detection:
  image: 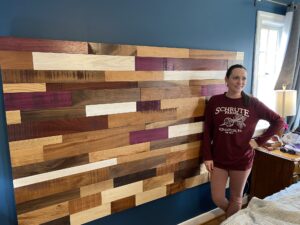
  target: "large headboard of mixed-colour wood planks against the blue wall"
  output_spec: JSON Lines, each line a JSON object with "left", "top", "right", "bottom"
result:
{"left": 0, "top": 37, "right": 244, "bottom": 225}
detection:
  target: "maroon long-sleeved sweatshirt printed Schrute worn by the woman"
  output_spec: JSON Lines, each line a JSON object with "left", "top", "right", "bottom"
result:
{"left": 202, "top": 93, "right": 283, "bottom": 170}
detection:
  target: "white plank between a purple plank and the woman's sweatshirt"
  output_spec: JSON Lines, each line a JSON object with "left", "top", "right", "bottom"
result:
{"left": 168, "top": 122, "right": 203, "bottom": 138}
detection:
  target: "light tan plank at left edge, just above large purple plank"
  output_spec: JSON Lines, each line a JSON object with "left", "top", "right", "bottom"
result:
{"left": 3, "top": 83, "right": 46, "bottom": 93}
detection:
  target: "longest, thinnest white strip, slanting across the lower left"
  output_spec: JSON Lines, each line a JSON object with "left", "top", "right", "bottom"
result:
{"left": 13, "top": 158, "right": 117, "bottom": 188}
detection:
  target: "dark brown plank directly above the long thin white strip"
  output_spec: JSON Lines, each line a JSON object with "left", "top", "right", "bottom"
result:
{"left": 13, "top": 154, "right": 89, "bottom": 179}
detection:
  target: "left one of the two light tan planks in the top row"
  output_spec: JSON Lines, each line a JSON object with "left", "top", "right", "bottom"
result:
{"left": 137, "top": 46, "right": 189, "bottom": 58}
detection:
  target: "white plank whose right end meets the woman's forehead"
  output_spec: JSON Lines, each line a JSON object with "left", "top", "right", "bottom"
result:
{"left": 164, "top": 70, "right": 226, "bottom": 80}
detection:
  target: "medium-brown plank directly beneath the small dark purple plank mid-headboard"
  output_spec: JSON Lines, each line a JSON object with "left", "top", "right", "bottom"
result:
{"left": 108, "top": 109, "right": 177, "bottom": 128}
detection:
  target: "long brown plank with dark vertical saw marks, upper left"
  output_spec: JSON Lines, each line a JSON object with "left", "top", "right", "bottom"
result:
{"left": 2, "top": 68, "right": 105, "bottom": 83}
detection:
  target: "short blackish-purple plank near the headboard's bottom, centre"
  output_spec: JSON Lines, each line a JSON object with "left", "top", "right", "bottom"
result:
{"left": 114, "top": 168, "right": 156, "bottom": 187}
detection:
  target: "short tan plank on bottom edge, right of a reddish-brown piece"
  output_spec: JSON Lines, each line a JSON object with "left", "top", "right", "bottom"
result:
{"left": 135, "top": 186, "right": 167, "bottom": 205}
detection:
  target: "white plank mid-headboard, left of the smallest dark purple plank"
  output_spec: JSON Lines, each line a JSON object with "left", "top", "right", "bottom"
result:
{"left": 85, "top": 102, "right": 136, "bottom": 116}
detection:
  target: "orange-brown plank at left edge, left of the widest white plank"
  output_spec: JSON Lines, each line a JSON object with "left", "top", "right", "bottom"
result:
{"left": 0, "top": 51, "right": 33, "bottom": 70}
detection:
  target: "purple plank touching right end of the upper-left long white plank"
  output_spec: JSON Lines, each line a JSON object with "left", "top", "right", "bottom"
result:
{"left": 135, "top": 57, "right": 166, "bottom": 71}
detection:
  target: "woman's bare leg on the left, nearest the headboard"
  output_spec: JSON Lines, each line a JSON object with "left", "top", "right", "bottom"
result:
{"left": 210, "top": 167, "right": 228, "bottom": 211}
